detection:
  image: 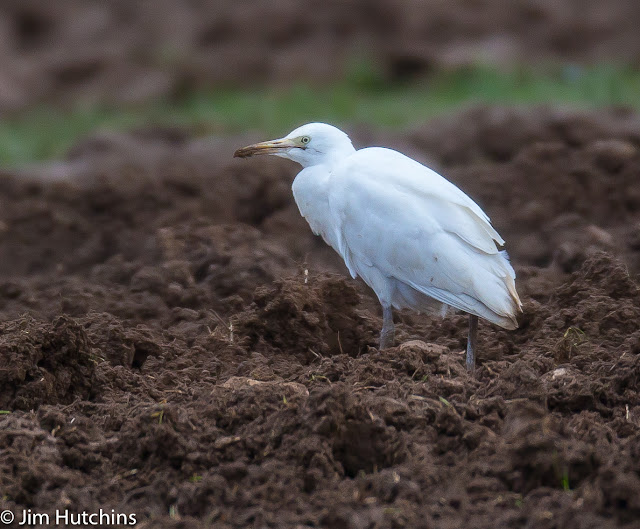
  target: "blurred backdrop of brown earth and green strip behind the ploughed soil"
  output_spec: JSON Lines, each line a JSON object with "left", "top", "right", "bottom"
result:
{"left": 0, "top": 0, "right": 640, "bottom": 165}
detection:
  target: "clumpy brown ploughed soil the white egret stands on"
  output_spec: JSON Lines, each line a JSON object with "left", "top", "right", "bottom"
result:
{"left": 0, "top": 105, "right": 640, "bottom": 529}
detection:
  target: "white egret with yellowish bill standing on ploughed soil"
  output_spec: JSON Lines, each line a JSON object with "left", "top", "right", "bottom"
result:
{"left": 234, "top": 123, "right": 522, "bottom": 370}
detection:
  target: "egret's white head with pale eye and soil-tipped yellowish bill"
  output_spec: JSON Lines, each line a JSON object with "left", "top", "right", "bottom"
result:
{"left": 233, "top": 123, "right": 355, "bottom": 167}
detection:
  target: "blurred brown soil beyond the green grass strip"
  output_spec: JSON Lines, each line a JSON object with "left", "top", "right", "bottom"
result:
{"left": 0, "top": 0, "right": 640, "bottom": 111}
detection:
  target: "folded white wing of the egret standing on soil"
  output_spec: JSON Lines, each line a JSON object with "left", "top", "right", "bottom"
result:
{"left": 328, "top": 144, "right": 520, "bottom": 328}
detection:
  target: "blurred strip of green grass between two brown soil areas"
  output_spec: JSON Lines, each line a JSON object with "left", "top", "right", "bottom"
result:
{"left": 0, "top": 64, "right": 640, "bottom": 166}
